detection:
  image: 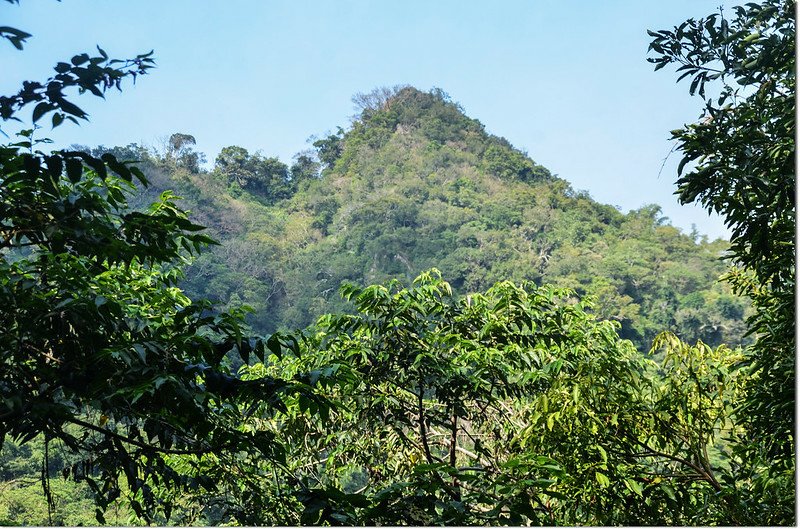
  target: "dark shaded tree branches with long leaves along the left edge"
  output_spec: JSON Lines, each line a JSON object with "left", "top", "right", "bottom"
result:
{"left": 0, "top": 9, "right": 324, "bottom": 524}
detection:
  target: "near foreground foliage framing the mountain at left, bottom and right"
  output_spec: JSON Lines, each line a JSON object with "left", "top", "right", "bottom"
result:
{"left": 0, "top": 0, "right": 794, "bottom": 525}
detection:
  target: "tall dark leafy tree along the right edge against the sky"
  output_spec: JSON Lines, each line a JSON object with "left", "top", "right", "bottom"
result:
{"left": 648, "top": 0, "right": 796, "bottom": 524}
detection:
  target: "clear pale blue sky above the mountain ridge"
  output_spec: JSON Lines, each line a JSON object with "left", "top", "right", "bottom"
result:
{"left": 0, "top": 0, "right": 737, "bottom": 238}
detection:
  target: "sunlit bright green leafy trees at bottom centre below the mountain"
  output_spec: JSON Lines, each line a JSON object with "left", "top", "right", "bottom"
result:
{"left": 241, "top": 270, "right": 751, "bottom": 525}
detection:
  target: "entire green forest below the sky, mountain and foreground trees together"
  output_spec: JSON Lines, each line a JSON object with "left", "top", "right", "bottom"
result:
{"left": 0, "top": 0, "right": 796, "bottom": 525}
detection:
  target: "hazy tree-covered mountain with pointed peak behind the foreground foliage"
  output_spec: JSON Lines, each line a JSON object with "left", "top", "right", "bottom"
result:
{"left": 101, "top": 87, "right": 746, "bottom": 351}
